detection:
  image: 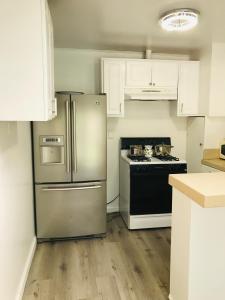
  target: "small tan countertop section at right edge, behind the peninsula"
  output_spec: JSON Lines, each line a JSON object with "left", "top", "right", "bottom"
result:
{"left": 202, "top": 149, "right": 225, "bottom": 172}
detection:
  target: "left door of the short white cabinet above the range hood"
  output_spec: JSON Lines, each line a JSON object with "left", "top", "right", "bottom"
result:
{"left": 126, "top": 60, "right": 152, "bottom": 87}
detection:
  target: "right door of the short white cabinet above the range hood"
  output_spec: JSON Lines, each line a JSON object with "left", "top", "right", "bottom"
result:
{"left": 152, "top": 61, "right": 178, "bottom": 87}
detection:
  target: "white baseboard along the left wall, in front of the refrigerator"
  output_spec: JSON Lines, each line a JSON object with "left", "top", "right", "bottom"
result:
{"left": 16, "top": 237, "right": 37, "bottom": 300}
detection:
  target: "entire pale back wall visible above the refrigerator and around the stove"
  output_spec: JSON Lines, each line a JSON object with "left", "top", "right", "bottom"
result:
{"left": 55, "top": 49, "right": 186, "bottom": 211}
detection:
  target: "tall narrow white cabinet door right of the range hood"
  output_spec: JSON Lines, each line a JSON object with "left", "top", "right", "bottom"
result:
{"left": 177, "top": 61, "right": 199, "bottom": 116}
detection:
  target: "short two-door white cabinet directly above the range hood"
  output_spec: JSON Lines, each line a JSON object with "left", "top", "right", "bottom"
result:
{"left": 126, "top": 59, "right": 178, "bottom": 87}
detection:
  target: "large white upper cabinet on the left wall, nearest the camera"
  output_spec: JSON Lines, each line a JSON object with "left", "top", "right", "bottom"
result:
{"left": 0, "top": 0, "right": 55, "bottom": 121}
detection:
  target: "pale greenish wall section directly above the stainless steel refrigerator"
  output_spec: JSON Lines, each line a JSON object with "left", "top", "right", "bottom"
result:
{"left": 55, "top": 49, "right": 142, "bottom": 94}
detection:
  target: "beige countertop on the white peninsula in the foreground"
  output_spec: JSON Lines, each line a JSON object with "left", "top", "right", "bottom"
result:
{"left": 169, "top": 172, "right": 225, "bottom": 208}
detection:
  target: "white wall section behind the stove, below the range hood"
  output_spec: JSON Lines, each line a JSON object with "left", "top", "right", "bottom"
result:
{"left": 108, "top": 101, "right": 186, "bottom": 212}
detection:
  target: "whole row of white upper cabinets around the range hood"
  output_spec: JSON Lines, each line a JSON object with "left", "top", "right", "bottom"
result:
{"left": 102, "top": 58, "right": 200, "bottom": 117}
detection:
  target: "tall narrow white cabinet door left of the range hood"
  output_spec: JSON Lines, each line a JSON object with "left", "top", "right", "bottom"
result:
{"left": 102, "top": 59, "right": 125, "bottom": 117}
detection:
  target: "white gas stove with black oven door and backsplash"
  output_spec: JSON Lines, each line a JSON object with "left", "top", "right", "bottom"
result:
{"left": 120, "top": 138, "right": 187, "bottom": 229}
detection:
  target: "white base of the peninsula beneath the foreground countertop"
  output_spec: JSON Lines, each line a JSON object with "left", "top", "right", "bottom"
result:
{"left": 169, "top": 190, "right": 225, "bottom": 300}
